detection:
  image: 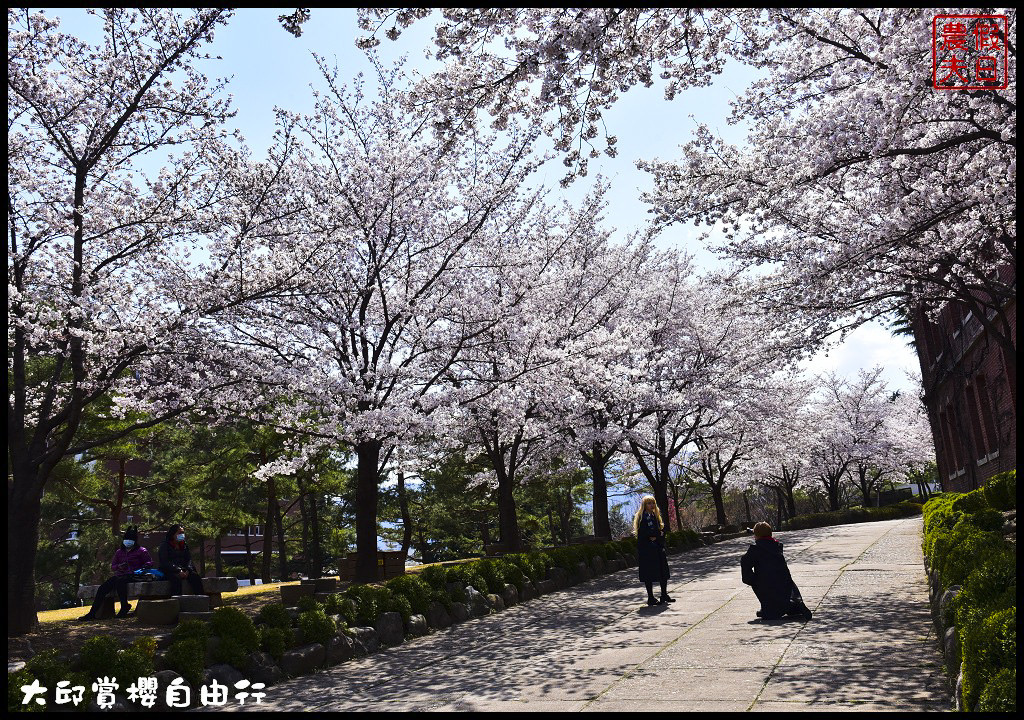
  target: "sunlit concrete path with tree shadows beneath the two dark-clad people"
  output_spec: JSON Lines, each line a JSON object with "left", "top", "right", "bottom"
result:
{"left": 225, "top": 517, "right": 950, "bottom": 712}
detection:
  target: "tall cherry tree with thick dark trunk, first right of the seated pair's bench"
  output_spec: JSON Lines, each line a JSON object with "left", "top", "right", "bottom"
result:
{"left": 233, "top": 60, "right": 537, "bottom": 581}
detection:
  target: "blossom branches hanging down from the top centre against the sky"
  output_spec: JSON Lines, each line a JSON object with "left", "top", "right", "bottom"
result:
{"left": 358, "top": 7, "right": 765, "bottom": 184}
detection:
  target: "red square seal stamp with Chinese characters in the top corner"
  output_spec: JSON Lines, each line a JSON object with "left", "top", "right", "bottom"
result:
{"left": 932, "top": 15, "right": 1010, "bottom": 90}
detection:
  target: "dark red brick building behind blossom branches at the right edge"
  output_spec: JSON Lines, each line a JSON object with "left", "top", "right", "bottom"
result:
{"left": 913, "top": 266, "right": 1017, "bottom": 492}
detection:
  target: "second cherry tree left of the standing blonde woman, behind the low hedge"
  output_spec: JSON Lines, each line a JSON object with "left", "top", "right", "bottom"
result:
{"left": 451, "top": 184, "right": 625, "bottom": 549}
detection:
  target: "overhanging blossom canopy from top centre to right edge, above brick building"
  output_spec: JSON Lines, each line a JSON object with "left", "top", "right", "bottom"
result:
{"left": 360, "top": 8, "right": 1017, "bottom": 359}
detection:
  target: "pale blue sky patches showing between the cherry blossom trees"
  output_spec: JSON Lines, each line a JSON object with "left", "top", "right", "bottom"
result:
{"left": 46, "top": 8, "right": 920, "bottom": 392}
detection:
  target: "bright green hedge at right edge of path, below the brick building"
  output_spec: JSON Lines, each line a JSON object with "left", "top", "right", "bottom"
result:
{"left": 923, "top": 471, "right": 1017, "bottom": 712}
